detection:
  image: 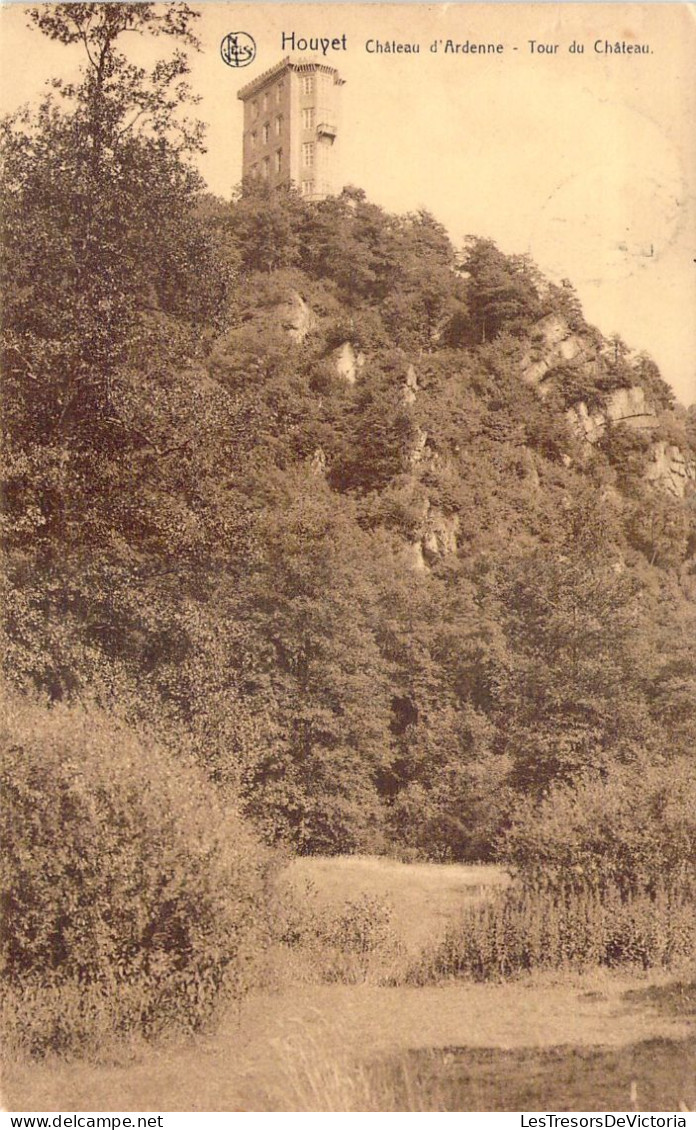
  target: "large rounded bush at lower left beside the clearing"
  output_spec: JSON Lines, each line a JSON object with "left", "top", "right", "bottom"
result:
{"left": 0, "top": 695, "right": 270, "bottom": 1053}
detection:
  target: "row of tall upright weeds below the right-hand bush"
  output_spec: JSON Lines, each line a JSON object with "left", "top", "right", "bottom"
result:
{"left": 410, "top": 887, "right": 696, "bottom": 983}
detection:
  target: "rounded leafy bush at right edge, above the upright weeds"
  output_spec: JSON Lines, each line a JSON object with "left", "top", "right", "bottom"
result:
{"left": 501, "top": 760, "right": 696, "bottom": 896}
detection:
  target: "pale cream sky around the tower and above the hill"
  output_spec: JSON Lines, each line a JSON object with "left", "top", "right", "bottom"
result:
{"left": 0, "top": 2, "right": 696, "bottom": 405}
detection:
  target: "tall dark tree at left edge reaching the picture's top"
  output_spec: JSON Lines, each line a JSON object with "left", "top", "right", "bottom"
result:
{"left": 1, "top": 3, "right": 230, "bottom": 694}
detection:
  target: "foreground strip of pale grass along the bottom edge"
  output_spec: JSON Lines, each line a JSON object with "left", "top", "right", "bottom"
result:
{"left": 5, "top": 974, "right": 693, "bottom": 1111}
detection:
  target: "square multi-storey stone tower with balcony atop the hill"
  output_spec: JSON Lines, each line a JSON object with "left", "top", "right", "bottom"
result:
{"left": 237, "top": 58, "right": 343, "bottom": 200}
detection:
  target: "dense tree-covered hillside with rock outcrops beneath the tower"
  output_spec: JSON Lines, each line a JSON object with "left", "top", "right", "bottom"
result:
{"left": 5, "top": 171, "right": 696, "bottom": 859}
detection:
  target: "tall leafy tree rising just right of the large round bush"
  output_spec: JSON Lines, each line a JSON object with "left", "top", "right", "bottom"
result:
{"left": 217, "top": 471, "right": 397, "bottom": 852}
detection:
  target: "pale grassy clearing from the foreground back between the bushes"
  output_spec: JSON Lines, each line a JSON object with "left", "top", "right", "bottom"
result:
{"left": 5, "top": 858, "right": 696, "bottom": 1112}
